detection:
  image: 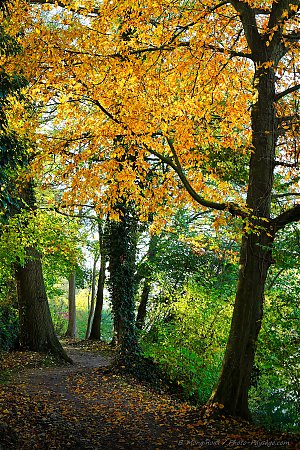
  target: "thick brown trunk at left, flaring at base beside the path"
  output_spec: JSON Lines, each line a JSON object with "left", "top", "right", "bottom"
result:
{"left": 16, "top": 248, "right": 72, "bottom": 362}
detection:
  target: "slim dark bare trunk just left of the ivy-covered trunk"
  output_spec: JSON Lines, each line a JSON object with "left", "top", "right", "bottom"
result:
{"left": 89, "top": 222, "right": 107, "bottom": 341}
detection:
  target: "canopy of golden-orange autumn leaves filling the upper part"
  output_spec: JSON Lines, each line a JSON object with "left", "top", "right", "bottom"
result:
{"left": 4, "top": 0, "right": 298, "bottom": 226}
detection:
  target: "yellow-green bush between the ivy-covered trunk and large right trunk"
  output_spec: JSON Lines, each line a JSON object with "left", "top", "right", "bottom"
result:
{"left": 142, "top": 284, "right": 232, "bottom": 403}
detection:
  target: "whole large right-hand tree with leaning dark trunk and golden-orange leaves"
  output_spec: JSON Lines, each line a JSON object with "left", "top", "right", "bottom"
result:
{"left": 11, "top": 0, "right": 300, "bottom": 418}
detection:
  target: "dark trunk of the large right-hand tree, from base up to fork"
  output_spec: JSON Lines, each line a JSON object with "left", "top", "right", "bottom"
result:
{"left": 210, "top": 57, "right": 277, "bottom": 418}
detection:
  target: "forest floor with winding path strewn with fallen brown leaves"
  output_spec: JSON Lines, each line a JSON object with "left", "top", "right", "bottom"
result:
{"left": 0, "top": 342, "right": 300, "bottom": 450}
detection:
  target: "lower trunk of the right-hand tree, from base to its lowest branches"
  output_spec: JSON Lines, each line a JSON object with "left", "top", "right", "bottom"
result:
{"left": 211, "top": 234, "right": 271, "bottom": 419}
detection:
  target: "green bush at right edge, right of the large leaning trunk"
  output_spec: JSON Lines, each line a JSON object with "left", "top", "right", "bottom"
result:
{"left": 250, "top": 288, "right": 300, "bottom": 431}
